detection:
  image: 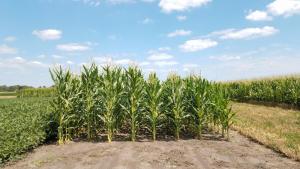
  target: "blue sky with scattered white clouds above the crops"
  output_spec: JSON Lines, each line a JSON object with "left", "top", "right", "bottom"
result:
{"left": 0, "top": 0, "right": 300, "bottom": 86}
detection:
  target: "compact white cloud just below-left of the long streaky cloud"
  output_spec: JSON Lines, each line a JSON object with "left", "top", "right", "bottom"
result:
{"left": 179, "top": 39, "right": 218, "bottom": 52}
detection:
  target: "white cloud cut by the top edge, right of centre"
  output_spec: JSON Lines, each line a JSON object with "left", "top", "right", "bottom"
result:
{"left": 159, "top": 0, "right": 211, "bottom": 13}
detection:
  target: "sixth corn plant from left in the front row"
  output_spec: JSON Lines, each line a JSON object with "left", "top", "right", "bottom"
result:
{"left": 166, "top": 74, "right": 187, "bottom": 140}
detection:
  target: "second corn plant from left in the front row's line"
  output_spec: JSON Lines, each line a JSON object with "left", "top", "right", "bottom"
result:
{"left": 81, "top": 64, "right": 99, "bottom": 140}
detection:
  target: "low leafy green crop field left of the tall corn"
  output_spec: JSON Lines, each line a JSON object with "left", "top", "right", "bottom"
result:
{"left": 0, "top": 98, "right": 51, "bottom": 164}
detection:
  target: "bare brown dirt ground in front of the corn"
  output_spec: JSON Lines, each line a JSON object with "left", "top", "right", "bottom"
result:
{"left": 5, "top": 131, "right": 300, "bottom": 169}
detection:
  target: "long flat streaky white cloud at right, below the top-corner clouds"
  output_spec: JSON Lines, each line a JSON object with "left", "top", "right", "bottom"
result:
{"left": 221, "top": 26, "right": 279, "bottom": 39}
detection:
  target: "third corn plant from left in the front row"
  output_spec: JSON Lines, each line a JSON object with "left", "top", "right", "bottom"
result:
{"left": 98, "top": 66, "right": 124, "bottom": 142}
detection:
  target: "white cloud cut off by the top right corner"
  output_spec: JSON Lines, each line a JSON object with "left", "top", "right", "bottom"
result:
{"left": 267, "top": 0, "right": 300, "bottom": 16}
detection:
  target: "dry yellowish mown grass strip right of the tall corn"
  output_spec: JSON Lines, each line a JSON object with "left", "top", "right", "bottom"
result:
{"left": 232, "top": 103, "right": 300, "bottom": 160}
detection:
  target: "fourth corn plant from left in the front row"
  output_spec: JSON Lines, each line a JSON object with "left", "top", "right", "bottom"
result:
{"left": 123, "top": 67, "right": 145, "bottom": 141}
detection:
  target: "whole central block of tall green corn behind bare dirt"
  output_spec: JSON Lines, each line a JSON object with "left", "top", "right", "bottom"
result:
{"left": 51, "top": 64, "right": 234, "bottom": 144}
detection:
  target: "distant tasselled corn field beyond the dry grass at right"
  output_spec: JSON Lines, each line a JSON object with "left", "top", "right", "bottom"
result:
{"left": 225, "top": 76, "right": 300, "bottom": 107}
